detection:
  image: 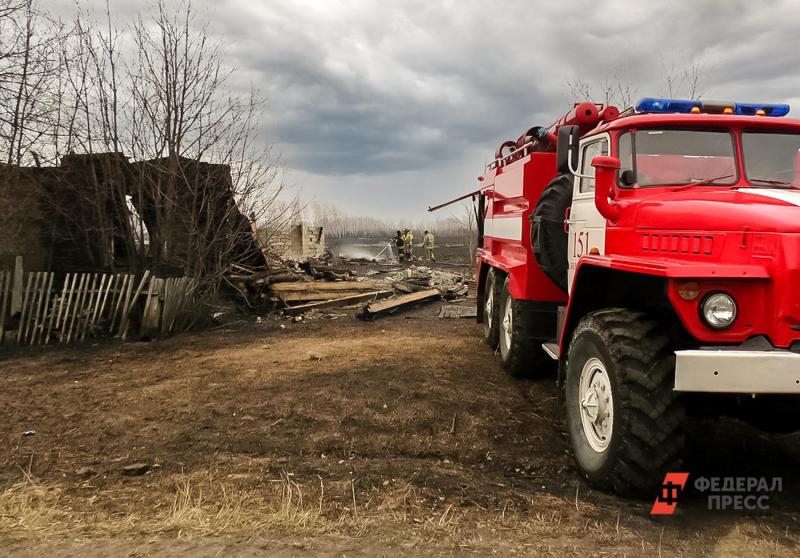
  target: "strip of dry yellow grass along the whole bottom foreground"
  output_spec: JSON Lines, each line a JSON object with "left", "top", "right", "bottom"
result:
{"left": 0, "top": 472, "right": 797, "bottom": 555}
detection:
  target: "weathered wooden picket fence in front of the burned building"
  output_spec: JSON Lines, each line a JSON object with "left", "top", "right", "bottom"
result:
{"left": 0, "top": 262, "right": 195, "bottom": 345}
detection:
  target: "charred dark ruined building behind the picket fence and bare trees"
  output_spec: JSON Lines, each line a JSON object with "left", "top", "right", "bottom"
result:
{"left": 0, "top": 153, "right": 266, "bottom": 276}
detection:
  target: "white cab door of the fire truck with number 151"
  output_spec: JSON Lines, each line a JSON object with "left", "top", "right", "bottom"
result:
{"left": 567, "top": 134, "right": 609, "bottom": 291}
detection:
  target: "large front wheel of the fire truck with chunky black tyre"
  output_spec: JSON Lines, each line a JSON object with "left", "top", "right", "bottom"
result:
{"left": 565, "top": 308, "right": 686, "bottom": 497}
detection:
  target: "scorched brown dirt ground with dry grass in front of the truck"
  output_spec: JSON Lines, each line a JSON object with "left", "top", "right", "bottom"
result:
{"left": 0, "top": 290, "right": 800, "bottom": 557}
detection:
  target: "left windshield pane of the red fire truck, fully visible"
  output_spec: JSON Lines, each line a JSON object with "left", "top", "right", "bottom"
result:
{"left": 618, "top": 129, "right": 737, "bottom": 187}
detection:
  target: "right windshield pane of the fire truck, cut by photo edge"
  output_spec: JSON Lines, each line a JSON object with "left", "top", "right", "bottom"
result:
{"left": 742, "top": 131, "right": 800, "bottom": 185}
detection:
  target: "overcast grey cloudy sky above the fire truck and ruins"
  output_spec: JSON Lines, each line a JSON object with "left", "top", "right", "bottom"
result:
{"left": 57, "top": 0, "right": 800, "bottom": 219}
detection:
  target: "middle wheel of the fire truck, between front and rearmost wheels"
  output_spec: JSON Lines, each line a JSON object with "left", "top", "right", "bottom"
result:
{"left": 497, "top": 277, "right": 555, "bottom": 378}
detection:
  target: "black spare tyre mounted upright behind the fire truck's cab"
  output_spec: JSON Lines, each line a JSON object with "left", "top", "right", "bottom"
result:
{"left": 531, "top": 174, "right": 572, "bottom": 292}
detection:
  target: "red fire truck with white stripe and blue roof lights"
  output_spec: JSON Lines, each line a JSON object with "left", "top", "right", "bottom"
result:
{"left": 432, "top": 98, "right": 800, "bottom": 494}
